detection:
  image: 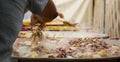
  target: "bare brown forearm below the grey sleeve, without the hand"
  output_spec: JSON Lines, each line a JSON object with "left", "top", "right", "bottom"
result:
{"left": 35, "top": 0, "right": 58, "bottom": 22}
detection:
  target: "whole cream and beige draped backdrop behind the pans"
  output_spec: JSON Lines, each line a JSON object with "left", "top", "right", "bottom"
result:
{"left": 24, "top": 0, "right": 120, "bottom": 37}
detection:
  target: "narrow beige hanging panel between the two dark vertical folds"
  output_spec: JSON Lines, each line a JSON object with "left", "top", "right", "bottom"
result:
{"left": 93, "top": 0, "right": 104, "bottom": 33}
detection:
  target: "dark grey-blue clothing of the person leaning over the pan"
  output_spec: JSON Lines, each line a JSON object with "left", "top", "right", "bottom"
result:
{"left": 0, "top": 0, "right": 48, "bottom": 62}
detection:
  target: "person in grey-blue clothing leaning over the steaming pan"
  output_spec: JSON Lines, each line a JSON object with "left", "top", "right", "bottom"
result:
{"left": 0, "top": 0, "right": 58, "bottom": 62}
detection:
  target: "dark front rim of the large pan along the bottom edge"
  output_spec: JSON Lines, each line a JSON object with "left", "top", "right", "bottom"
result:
{"left": 12, "top": 57, "right": 120, "bottom": 62}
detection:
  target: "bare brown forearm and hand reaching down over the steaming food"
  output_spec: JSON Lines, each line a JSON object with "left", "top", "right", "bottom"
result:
{"left": 31, "top": 0, "right": 58, "bottom": 28}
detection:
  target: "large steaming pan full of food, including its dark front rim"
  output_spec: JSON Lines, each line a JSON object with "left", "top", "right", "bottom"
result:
{"left": 12, "top": 31, "right": 120, "bottom": 62}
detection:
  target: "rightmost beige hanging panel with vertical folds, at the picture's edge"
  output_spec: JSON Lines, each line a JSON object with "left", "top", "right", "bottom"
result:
{"left": 105, "top": 0, "right": 120, "bottom": 37}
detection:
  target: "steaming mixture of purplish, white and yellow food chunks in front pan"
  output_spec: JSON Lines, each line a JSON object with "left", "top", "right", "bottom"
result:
{"left": 12, "top": 38, "right": 120, "bottom": 58}
